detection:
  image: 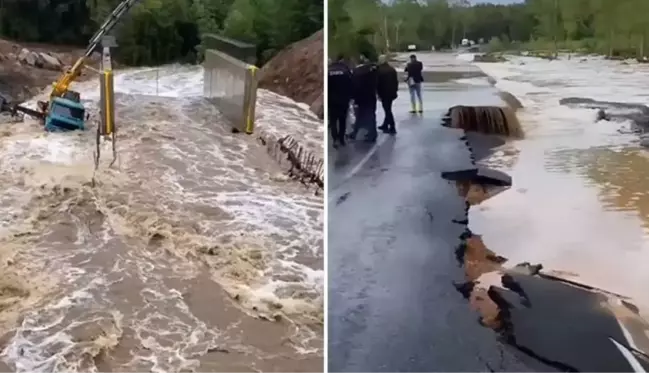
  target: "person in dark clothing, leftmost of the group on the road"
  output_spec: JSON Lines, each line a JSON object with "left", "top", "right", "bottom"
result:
{"left": 327, "top": 55, "right": 353, "bottom": 148}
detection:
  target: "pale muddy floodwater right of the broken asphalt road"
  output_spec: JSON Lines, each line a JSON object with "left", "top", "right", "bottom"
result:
{"left": 454, "top": 57, "right": 649, "bottom": 309}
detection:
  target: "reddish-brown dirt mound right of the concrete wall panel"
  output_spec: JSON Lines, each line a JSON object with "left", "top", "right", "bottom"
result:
{"left": 259, "top": 30, "right": 324, "bottom": 118}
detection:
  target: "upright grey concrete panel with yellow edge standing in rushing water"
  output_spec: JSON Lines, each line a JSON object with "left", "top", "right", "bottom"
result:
{"left": 203, "top": 49, "right": 258, "bottom": 134}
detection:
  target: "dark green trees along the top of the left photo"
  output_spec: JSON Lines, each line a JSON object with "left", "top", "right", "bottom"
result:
{"left": 0, "top": 0, "right": 324, "bottom": 65}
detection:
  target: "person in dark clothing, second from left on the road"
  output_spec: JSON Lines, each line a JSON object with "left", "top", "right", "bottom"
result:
{"left": 349, "top": 56, "right": 378, "bottom": 142}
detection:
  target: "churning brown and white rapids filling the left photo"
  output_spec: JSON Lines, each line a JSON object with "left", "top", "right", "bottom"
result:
{"left": 0, "top": 65, "right": 323, "bottom": 373}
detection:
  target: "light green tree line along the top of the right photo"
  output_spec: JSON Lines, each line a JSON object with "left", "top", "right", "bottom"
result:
{"left": 329, "top": 0, "right": 649, "bottom": 58}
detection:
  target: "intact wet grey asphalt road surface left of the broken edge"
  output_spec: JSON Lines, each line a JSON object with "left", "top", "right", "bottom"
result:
{"left": 328, "top": 84, "right": 531, "bottom": 373}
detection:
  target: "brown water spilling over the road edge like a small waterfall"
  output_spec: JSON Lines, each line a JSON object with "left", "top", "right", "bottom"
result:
{"left": 443, "top": 106, "right": 523, "bottom": 138}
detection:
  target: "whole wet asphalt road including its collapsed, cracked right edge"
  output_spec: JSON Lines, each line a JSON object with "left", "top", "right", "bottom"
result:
{"left": 328, "top": 55, "right": 648, "bottom": 373}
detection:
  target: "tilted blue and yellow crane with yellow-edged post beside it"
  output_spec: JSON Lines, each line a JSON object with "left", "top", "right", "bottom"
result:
{"left": 0, "top": 0, "right": 139, "bottom": 135}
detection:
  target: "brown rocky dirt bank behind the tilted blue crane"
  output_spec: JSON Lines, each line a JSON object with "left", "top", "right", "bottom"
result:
{"left": 0, "top": 39, "right": 98, "bottom": 101}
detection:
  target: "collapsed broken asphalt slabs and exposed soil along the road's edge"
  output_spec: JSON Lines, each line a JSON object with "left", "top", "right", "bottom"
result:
{"left": 443, "top": 114, "right": 649, "bottom": 373}
